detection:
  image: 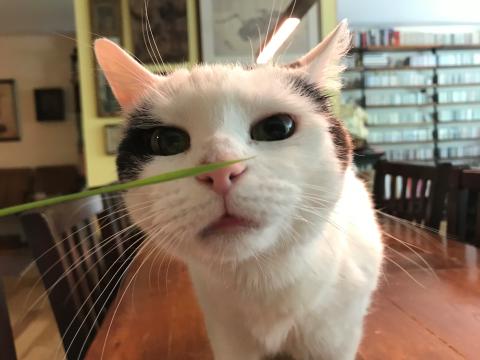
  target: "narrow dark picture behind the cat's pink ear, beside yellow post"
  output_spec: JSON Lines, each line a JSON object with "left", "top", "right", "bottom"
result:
{"left": 90, "top": 0, "right": 123, "bottom": 117}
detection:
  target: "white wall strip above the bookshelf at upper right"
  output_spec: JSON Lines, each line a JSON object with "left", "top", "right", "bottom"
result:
{"left": 337, "top": 0, "right": 480, "bottom": 26}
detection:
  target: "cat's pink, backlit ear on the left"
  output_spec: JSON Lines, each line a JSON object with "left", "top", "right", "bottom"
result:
{"left": 94, "top": 39, "right": 159, "bottom": 111}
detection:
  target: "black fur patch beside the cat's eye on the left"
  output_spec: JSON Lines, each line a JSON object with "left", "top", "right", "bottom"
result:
{"left": 117, "top": 106, "right": 153, "bottom": 181}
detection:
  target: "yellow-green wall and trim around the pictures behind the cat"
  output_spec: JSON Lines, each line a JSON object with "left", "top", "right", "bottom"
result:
{"left": 74, "top": 0, "right": 336, "bottom": 186}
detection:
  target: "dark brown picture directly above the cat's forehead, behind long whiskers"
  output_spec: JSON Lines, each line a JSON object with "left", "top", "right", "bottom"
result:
{"left": 129, "top": 0, "right": 190, "bottom": 64}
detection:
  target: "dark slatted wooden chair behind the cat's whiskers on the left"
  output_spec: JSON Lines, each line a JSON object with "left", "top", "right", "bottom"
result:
{"left": 21, "top": 196, "right": 141, "bottom": 359}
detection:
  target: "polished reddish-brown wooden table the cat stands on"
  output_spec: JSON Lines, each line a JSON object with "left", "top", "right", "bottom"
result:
{"left": 87, "top": 218, "right": 480, "bottom": 360}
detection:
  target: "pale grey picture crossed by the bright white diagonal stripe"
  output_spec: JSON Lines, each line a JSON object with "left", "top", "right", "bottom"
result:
{"left": 200, "top": 0, "right": 320, "bottom": 64}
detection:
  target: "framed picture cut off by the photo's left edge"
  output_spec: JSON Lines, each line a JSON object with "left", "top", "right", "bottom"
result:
{"left": 0, "top": 79, "right": 20, "bottom": 141}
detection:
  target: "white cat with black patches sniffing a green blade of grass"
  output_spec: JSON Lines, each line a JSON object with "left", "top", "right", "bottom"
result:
{"left": 95, "top": 22, "right": 382, "bottom": 360}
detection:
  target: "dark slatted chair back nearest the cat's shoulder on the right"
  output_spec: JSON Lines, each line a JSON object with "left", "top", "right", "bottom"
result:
{"left": 373, "top": 160, "right": 452, "bottom": 229}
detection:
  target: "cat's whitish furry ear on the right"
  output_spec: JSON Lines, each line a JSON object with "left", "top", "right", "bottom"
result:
{"left": 287, "top": 19, "right": 351, "bottom": 90}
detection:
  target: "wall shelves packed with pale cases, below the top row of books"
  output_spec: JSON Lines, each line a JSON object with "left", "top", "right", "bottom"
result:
{"left": 342, "top": 44, "right": 480, "bottom": 166}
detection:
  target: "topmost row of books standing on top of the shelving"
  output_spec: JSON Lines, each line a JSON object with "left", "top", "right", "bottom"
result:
{"left": 352, "top": 28, "right": 480, "bottom": 47}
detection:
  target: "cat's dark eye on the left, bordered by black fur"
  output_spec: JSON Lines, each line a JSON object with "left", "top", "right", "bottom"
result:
{"left": 150, "top": 126, "right": 190, "bottom": 156}
